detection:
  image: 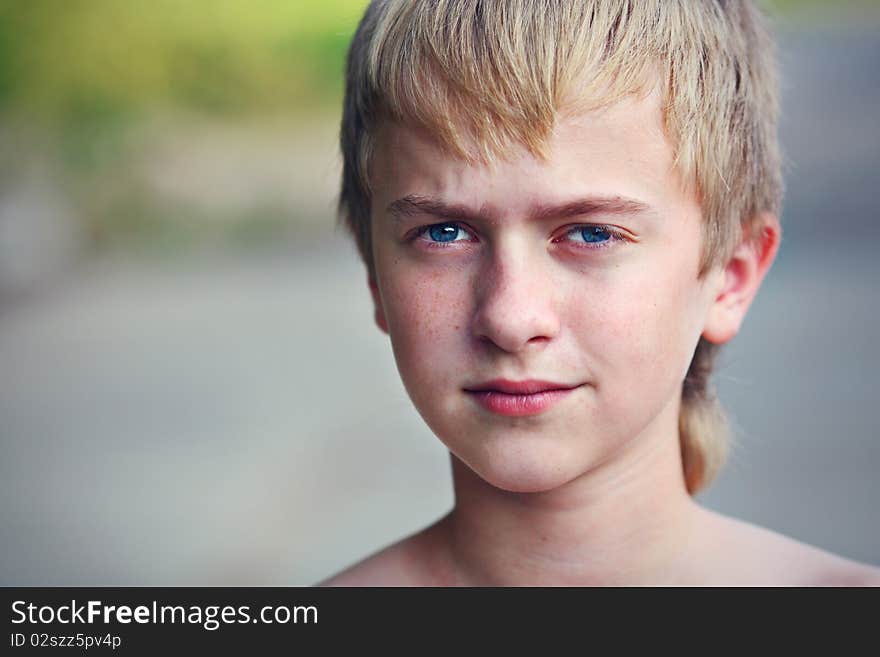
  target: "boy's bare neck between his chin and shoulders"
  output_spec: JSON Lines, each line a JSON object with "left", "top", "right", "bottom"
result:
{"left": 438, "top": 410, "right": 700, "bottom": 586}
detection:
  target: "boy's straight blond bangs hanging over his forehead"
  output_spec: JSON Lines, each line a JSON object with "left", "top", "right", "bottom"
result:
{"left": 367, "top": 0, "right": 667, "bottom": 161}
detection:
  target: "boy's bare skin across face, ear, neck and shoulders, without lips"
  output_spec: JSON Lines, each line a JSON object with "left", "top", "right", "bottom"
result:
{"left": 323, "top": 89, "right": 880, "bottom": 586}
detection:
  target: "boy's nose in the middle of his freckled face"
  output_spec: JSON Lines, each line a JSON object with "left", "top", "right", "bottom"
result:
{"left": 473, "top": 245, "right": 560, "bottom": 353}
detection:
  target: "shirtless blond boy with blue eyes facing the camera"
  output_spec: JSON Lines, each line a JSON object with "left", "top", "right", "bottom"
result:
{"left": 325, "top": 0, "right": 880, "bottom": 585}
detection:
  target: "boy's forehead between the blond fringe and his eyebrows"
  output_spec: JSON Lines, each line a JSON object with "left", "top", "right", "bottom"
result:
{"left": 370, "top": 85, "right": 695, "bottom": 215}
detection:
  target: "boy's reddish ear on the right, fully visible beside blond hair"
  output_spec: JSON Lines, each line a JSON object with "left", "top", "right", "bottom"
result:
{"left": 703, "top": 212, "right": 782, "bottom": 344}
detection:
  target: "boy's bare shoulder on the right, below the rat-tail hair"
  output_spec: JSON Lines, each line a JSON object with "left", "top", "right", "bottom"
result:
{"left": 707, "top": 513, "right": 880, "bottom": 586}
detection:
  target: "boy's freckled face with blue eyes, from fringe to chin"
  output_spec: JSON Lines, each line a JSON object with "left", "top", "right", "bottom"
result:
{"left": 371, "top": 88, "right": 745, "bottom": 491}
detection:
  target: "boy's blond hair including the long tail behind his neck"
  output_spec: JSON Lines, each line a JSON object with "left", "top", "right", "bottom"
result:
{"left": 340, "top": 0, "right": 782, "bottom": 493}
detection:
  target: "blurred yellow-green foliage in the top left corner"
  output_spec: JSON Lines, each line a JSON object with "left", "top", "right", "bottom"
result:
{"left": 0, "top": 0, "right": 366, "bottom": 121}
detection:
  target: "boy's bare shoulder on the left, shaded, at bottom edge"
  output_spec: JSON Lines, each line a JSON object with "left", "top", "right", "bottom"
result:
{"left": 317, "top": 523, "right": 449, "bottom": 586}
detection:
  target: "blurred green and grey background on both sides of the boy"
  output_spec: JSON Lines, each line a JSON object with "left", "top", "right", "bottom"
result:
{"left": 0, "top": 0, "right": 880, "bottom": 585}
